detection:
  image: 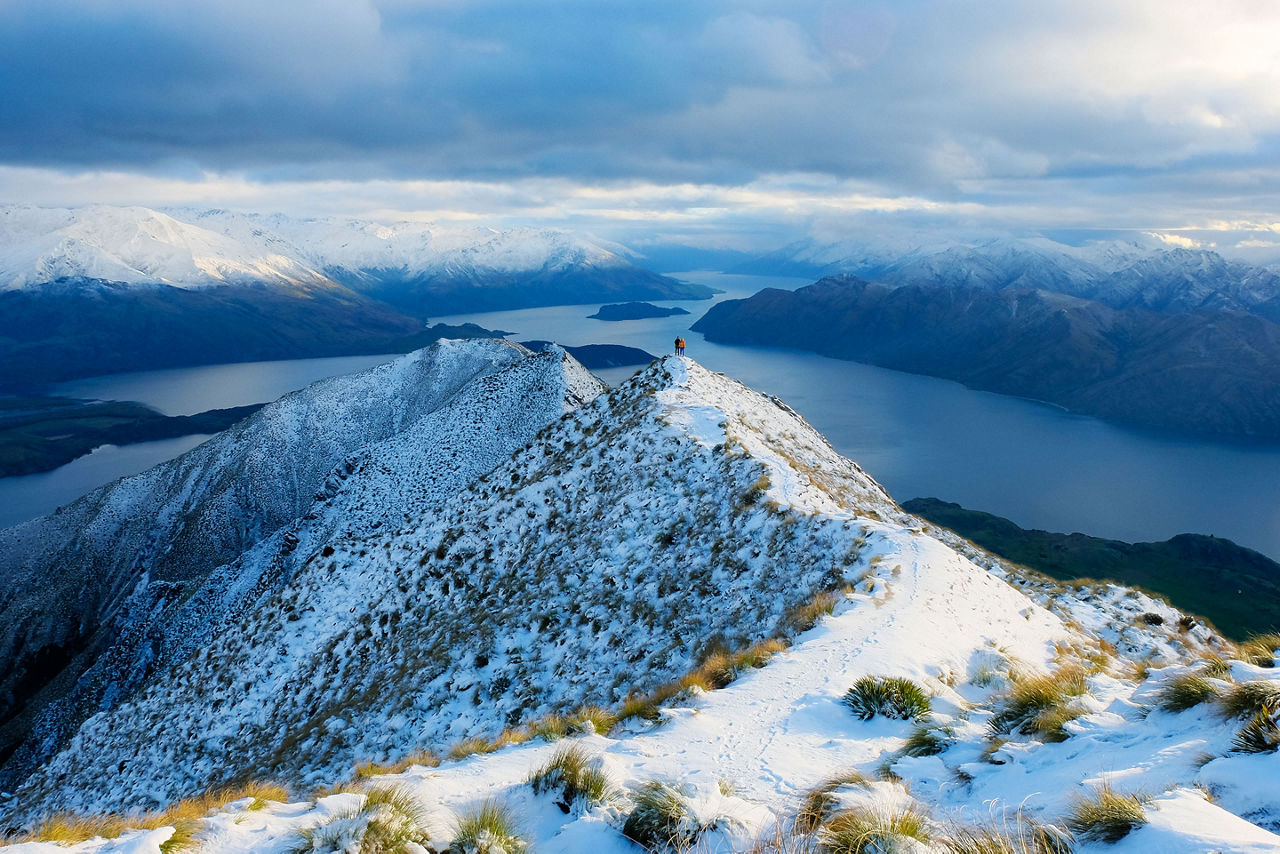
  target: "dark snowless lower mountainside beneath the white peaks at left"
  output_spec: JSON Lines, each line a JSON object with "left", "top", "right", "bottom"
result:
{"left": 0, "top": 279, "right": 496, "bottom": 389}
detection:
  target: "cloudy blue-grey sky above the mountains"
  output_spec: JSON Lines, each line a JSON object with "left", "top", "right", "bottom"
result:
{"left": 0, "top": 0, "right": 1280, "bottom": 255}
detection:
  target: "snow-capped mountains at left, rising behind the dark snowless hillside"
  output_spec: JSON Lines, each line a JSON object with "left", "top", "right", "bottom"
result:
{"left": 0, "top": 205, "right": 712, "bottom": 314}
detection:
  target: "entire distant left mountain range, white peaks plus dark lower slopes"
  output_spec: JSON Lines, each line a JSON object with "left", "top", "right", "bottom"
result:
{"left": 0, "top": 206, "right": 713, "bottom": 391}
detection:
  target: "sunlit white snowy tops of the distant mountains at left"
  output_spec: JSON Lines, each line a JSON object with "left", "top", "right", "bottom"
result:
{"left": 0, "top": 205, "right": 630, "bottom": 289}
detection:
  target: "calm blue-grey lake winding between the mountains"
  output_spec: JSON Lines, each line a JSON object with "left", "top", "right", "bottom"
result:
{"left": 0, "top": 273, "right": 1280, "bottom": 560}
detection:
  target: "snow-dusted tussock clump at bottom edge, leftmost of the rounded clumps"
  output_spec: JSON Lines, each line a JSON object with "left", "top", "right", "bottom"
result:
{"left": 292, "top": 786, "right": 430, "bottom": 854}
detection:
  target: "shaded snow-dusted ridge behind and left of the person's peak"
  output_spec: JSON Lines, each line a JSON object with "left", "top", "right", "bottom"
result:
{"left": 0, "top": 341, "right": 588, "bottom": 781}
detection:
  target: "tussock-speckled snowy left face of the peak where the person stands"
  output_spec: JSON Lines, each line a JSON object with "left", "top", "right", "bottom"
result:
{"left": 12, "top": 360, "right": 899, "bottom": 819}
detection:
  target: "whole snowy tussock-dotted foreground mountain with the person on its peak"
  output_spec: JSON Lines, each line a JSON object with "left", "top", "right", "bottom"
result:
{"left": 9, "top": 356, "right": 1280, "bottom": 854}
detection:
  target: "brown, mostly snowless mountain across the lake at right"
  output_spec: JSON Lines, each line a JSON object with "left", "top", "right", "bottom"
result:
{"left": 692, "top": 275, "right": 1280, "bottom": 440}
